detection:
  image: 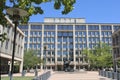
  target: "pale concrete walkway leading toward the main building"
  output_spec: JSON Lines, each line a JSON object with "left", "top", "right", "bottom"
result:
{"left": 48, "top": 71, "right": 110, "bottom": 80}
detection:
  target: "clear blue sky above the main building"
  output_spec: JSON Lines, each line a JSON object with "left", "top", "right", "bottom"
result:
{"left": 29, "top": 0, "right": 120, "bottom": 23}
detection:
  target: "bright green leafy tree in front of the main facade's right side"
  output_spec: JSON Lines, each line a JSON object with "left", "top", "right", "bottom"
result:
{"left": 83, "top": 43, "right": 113, "bottom": 68}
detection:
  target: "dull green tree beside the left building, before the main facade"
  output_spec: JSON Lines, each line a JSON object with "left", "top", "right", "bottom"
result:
{"left": 24, "top": 50, "right": 43, "bottom": 69}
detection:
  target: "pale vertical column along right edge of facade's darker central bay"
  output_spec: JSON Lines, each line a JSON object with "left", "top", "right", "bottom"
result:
{"left": 73, "top": 24, "right": 76, "bottom": 70}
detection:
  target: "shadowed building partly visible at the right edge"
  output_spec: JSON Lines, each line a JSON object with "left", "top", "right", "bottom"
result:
{"left": 112, "top": 29, "right": 120, "bottom": 71}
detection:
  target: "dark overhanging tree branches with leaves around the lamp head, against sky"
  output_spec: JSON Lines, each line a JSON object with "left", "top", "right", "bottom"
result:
{"left": 0, "top": 0, "right": 76, "bottom": 25}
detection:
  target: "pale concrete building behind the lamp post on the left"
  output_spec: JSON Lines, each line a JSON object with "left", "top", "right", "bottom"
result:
{"left": 0, "top": 17, "right": 25, "bottom": 73}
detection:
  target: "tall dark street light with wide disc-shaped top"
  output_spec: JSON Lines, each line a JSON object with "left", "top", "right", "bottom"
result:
{"left": 6, "top": 8, "right": 28, "bottom": 80}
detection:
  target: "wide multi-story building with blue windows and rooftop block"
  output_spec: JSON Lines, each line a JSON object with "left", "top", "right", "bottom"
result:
{"left": 19, "top": 18, "right": 120, "bottom": 70}
